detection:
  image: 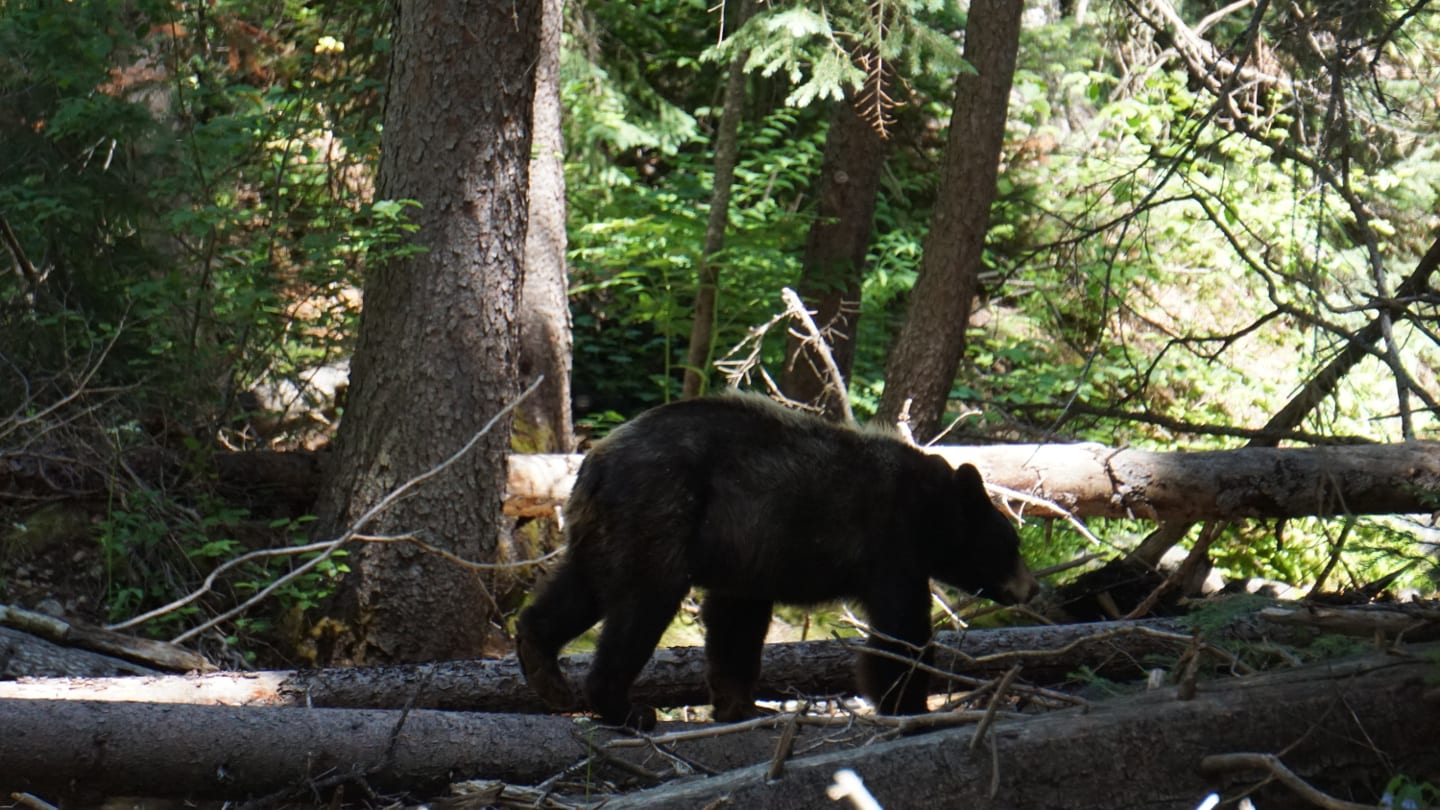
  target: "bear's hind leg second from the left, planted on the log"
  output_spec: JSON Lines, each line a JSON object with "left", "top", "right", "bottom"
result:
{"left": 585, "top": 587, "right": 688, "bottom": 731}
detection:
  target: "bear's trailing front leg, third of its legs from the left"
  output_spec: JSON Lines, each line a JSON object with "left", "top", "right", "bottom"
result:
{"left": 700, "top": 594, "right": 773, "bottom": 722}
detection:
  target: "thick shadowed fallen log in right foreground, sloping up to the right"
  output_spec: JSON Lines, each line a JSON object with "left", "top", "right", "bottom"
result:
{"left": 605, "top": 647, "right": 1440, "bottom": 810}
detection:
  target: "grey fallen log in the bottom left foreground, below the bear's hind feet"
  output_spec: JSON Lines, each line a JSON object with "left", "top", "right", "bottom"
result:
{"left": 0, "top": 699, "right": 877, "bottom": 806}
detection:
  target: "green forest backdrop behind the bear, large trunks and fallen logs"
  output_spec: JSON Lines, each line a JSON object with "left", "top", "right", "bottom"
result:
{"left": 0, "top": 0, "right": 1440, "bottom": 662}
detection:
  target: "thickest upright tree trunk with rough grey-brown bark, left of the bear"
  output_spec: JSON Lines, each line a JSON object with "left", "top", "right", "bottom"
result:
{"left": 313, "top": 0, "right": 540, "bottom": 663}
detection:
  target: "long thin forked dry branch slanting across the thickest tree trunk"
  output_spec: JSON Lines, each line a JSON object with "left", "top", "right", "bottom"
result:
{"left": 107, "top": 375, "right": 544, "bottom": 644}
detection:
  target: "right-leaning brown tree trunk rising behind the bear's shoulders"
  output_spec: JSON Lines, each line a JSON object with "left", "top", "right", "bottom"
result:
{"left": 877, "top": 0, "right": 1024, "bottom": 441}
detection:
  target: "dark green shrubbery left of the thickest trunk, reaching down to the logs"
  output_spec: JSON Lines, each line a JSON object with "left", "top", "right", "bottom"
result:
{"left": 0, "top": 0, "right": 400, "bottom": 657}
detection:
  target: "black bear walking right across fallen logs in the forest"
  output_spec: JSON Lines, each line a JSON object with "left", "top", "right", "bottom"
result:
{"left": 517, "top": 395, "right": 1038, "bottom": 729}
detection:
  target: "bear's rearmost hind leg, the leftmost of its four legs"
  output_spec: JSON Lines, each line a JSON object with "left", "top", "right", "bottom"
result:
{"left": 516, "top": 559, "right": 600, "bottom": 711}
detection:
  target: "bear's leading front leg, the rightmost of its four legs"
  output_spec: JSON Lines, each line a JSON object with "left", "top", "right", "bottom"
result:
{"left": 858, "top": 581, "right": 932, "bottom": 715}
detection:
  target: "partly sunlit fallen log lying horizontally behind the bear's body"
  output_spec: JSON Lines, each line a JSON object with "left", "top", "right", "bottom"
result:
{"left": 0, "top": 441, "right": 1440, "bottom": 520}
